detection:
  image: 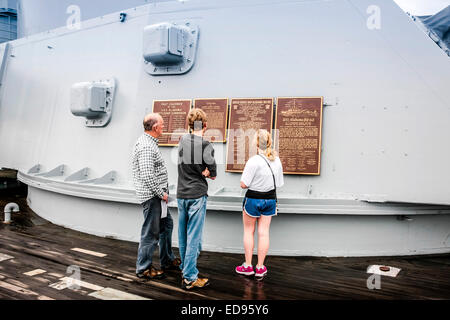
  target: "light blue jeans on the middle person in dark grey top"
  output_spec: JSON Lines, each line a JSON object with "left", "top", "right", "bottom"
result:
{"left": 177, "top": 196, "right": 207, "bottom": 281}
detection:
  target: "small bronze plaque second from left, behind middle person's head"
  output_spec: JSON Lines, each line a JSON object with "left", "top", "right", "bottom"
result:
{"left": 194, "top": 98, "right": 228, "bottom": 143}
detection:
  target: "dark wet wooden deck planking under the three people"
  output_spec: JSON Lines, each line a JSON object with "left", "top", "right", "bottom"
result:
{"left": 0, "top": 195, "right": 450, "bottom": 300}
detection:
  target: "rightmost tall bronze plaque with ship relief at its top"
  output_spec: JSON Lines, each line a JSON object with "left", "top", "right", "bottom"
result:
{"left": 275, "top": 97, "right": 323, "bottom": 175}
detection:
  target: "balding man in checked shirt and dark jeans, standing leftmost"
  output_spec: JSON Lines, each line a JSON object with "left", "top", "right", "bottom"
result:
{"left": 132, "top": 113, "right": 181, "bottom": 279}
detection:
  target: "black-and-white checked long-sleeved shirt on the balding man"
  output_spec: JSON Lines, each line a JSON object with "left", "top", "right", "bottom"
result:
{"left": 132, "top": 133, "right": 168, "bottom": 203}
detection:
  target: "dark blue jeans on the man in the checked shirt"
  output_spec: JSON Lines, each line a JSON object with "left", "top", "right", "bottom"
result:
{"left": 136, "top": 197, "right": 175, "bottom": 273}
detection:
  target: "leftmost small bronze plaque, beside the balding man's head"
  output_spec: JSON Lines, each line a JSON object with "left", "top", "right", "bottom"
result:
{"left": 153, "top": 100, "right": 191, "bottom": 146}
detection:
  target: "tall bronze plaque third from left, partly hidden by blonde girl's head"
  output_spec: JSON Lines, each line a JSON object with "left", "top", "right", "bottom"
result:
{"left": 225, "top": 98, "right": 273, "bottom": 172}
